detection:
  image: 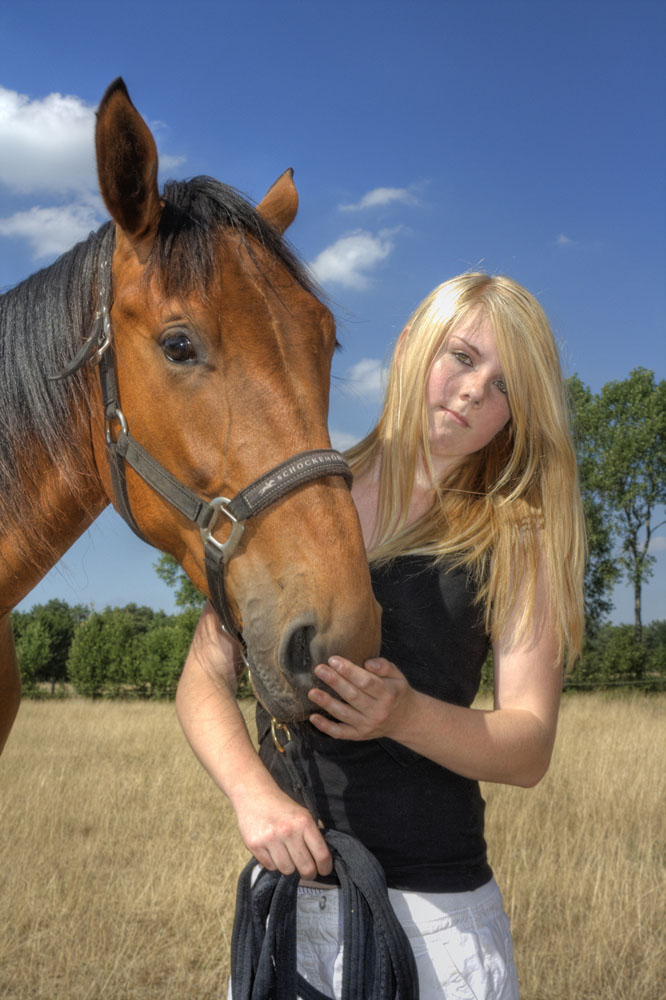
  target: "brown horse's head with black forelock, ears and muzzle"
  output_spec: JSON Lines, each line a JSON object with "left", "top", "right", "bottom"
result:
{"left": 92, "top": 80, "right": 379, "bottom": 721}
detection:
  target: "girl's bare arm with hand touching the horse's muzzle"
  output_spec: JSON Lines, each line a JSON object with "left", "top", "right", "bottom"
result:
{"left": 310, "top": 556, "right": 562, "bottom": 787}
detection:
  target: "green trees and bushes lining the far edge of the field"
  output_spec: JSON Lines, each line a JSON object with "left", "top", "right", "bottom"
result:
{"left": 12, "top": 368, "right": 666, "bottom": 698}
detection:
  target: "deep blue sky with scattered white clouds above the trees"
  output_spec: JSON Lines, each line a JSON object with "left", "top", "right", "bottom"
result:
{"left": 0, "top": 0, "right": 666, "bottom": 621}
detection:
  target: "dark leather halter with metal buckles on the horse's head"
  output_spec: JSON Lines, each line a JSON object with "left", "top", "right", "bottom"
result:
{"left": 49, "top": 226, "right": 352, "bottom": 659}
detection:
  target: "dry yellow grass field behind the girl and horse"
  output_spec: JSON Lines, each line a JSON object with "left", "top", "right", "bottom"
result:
{"left": 0, "top": 695, "right": 666, "bottom": 1000}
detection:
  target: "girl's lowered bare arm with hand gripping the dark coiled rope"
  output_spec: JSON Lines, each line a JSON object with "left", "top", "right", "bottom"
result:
{"left": 176, "top": 604, "right": 332, "bottom": 879}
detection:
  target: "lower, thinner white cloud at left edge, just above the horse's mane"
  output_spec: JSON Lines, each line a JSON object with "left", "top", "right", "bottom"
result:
{"left": 0, "top": 198, "right": 105, "bottom": 260}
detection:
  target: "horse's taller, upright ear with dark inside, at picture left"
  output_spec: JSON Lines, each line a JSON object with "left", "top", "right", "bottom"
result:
{"left": 95, "top": 77, "right": 162, "bottom": 248}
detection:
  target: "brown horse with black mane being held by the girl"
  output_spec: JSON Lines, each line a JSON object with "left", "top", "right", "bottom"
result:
{"left": 0, "top": 80, "right": 379, "bottom": 748}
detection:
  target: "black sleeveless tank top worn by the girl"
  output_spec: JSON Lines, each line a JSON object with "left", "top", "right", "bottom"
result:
{"left": 257, "top": 556, "right": 492, "bottom": 892}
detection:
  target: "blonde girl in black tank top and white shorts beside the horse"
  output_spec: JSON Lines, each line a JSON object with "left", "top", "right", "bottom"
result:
{"left": 177, "top": 274, "right": 585, "bottom": 1000}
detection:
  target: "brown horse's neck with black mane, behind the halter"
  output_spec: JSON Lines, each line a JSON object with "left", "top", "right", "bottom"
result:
{"left": 0, "top": 230, "right": 108, "bottom": 614}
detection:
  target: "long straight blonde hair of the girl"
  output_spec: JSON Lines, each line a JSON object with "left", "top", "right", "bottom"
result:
{"left": 347, "top": 273, "right": 585, "bottom": 664}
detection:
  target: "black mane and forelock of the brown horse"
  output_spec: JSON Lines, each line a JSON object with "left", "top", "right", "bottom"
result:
{"left": 0, "top": 177, "right": 320, "bottom": 533}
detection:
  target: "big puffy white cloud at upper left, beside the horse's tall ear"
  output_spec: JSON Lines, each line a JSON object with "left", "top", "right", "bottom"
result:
{"left": 0, "top": 87, "right": 97, "bottom": 194}
